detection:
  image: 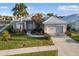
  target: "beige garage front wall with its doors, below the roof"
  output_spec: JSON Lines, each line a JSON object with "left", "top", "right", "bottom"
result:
{"left": 44, "top": 25, "right": 66, "bottom": 35}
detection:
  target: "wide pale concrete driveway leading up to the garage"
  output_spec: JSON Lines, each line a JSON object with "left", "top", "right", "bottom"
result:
{"left": 51, "top": 35, "right": 79, "bottom": 56}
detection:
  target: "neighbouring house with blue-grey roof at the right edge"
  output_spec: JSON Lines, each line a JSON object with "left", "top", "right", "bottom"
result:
{"left": 62, "top": 14, "right": 79, "bottom": 31}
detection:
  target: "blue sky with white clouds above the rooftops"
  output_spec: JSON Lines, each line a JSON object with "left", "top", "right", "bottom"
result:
{"left": 0, "top": 3, "right": 79, "bottom": 16}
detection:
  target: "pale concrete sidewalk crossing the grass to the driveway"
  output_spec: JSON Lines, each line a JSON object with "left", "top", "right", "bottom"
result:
{"left": 0, "top": 45, "right": 57, "bottom": 56}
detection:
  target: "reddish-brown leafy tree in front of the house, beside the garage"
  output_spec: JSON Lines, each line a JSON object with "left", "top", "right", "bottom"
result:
{"left": 32, "top": 13, "right": 43, "bottom": 31}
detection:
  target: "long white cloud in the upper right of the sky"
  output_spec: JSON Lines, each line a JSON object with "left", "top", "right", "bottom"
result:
{"left": 58, "top": 5, "right": 79, "bottom": 11}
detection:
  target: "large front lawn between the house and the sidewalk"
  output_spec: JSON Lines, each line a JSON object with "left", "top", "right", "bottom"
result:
{"left": 0, "top": 34, "right": 53, "bottom": 50}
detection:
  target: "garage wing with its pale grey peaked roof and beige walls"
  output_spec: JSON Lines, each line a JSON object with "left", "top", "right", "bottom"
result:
{"left": 43, "top": 17, "right": 67, "bottom": 35}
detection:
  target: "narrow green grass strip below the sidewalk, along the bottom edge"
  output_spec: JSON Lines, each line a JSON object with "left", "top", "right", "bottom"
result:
{"left": 11, "top": 50, "right": 58, "bottom": 56}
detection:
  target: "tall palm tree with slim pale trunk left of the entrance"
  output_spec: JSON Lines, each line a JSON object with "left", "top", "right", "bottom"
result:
{"left": 12, "top": 3, "right": 28, "bottom": 31}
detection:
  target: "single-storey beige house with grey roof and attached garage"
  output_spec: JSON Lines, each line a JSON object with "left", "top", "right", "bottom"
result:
{"left": 13, "top": 14, "right": 67, "bottom": 35}
